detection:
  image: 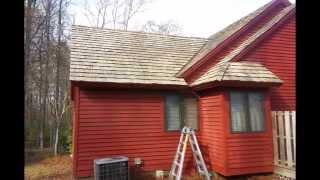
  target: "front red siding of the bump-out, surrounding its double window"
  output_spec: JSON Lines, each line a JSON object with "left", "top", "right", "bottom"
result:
{"left": 224, "top": 92, "right": 273, "bottom": 176}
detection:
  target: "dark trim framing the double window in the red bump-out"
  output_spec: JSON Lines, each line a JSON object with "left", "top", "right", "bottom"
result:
{"left": 228, "top": 90, "right": 267, "bottom": 134}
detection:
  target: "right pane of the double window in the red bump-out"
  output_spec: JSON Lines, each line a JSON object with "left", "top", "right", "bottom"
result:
{"left": 249, "top": 93, "right": 264, "bottom": 131}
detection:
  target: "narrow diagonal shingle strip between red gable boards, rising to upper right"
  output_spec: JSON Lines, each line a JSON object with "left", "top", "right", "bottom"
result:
{"left": 192, "top": 5, "right": 295, "bottom": 86}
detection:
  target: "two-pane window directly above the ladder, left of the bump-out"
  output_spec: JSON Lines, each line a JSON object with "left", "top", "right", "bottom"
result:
{"left": 165, "top": 95, "right": 198, "bottom": 131}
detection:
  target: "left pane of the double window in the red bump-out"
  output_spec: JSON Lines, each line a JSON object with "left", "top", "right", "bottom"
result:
{"left": 230, "top": 92, "right": 249, "bottom": 132}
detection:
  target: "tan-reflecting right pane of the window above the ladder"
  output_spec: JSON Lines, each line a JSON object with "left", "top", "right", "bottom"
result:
{"left": 183, "top": 98, "right": 198, "bottom": 129}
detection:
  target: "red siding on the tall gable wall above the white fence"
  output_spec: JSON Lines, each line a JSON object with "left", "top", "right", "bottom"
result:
{"left": 242, "top": 16, "right": 296, "bottom": 111}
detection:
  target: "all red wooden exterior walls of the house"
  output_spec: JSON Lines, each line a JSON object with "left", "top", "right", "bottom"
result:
{"left": 72, "top": 3, "right": 296, "bottom": 177}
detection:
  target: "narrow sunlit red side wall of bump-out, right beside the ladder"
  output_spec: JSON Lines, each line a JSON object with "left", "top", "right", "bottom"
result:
{"left": 199, "top": 91, "right": 226, "bottom": 174}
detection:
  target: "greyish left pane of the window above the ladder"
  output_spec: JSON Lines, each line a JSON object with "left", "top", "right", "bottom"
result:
{"left": 165, "top": 95, "right": 181, "bottom": 130}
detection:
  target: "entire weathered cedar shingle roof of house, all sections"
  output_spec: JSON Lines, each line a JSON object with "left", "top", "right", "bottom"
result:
{"left": 70, "top": 2, "right": 295, "bottom": 86}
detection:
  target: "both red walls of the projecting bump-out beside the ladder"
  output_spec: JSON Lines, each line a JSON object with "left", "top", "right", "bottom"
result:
{"left": 199, "top": 89, "right": 273, "bottom": 176}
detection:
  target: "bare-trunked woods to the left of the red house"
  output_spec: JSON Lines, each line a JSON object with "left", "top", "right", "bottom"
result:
{"left": 24, "top": 0, "right": 71, "bottom": 157}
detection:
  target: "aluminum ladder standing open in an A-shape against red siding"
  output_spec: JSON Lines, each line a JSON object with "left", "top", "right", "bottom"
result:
{"left": 169, "top": 127, "right": 210, "bottom": 180}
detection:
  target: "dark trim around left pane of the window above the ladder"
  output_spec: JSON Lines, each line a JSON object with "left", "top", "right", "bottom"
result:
{"left": 163, "top": 93, "right": 184, "bottom": 132}
